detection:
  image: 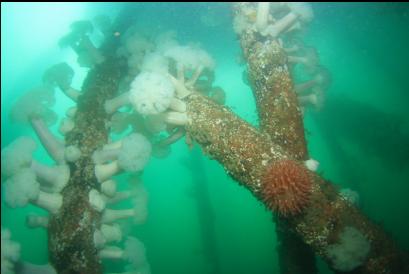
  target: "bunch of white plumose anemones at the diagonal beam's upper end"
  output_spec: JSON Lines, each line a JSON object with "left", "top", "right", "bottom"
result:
{"left": 105, "top": 30, "right": 215, "bottom": 128}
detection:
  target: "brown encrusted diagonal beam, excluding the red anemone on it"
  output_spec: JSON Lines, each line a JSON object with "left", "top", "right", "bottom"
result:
{"left": 186, "top": 94, "right": 408, "bottom": 274}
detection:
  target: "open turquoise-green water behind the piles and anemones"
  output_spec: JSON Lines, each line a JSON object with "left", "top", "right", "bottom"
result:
{"left": 1, "top": 3, "right": 409, "bottom": 274}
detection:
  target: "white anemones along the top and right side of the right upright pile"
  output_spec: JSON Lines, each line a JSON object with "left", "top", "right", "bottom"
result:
{"left": 233, "top": 2, "right": 330, "bottom": 110}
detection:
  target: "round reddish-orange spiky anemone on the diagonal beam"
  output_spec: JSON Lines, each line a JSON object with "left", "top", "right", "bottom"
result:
{"left": 261, "top": 160, "right": 311, "bottom": 216}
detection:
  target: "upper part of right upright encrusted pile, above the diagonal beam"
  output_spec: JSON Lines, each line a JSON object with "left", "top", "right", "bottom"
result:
{"left": 236, "top": 4, "right": 308, "bottom": 160}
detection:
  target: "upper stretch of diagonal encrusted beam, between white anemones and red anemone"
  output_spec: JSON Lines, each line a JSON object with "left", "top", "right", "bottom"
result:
{"left": 186, "top": 94, "right": 285, "bottom": 193}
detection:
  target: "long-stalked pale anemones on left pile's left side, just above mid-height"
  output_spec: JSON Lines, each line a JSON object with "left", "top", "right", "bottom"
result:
{"left": 10, "top": 63, "right": 85, "bottom": 164}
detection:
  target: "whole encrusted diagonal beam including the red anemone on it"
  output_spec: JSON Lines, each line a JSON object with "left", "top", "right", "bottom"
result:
{"left": 185, "top": 94, "right": 409, "bottom": 274}
